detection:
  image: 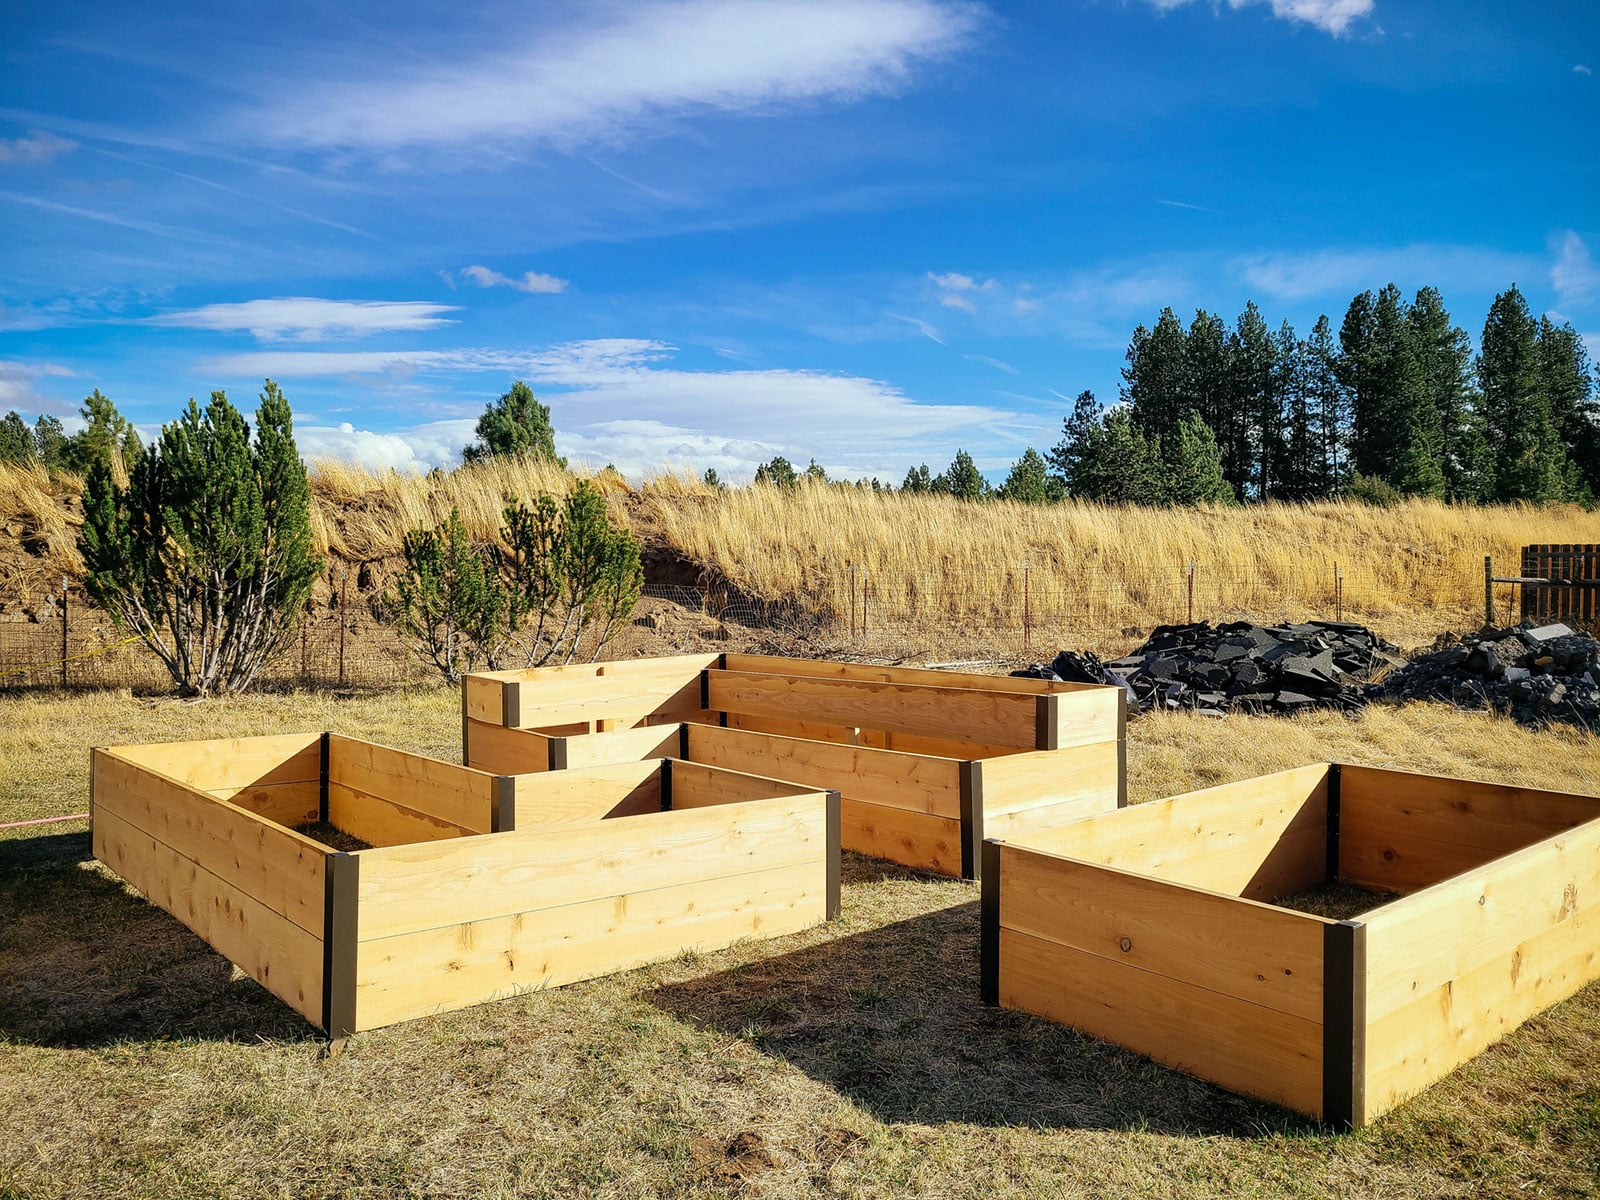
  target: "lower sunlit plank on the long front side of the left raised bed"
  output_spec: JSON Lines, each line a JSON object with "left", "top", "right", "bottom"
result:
{"left": 357, "top": 861, "right": 826, "bottom": 1029}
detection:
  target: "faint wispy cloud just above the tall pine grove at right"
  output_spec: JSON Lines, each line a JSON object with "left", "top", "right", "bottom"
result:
{"left": 1229, "top": 245, "right": 1542, "bottom": 299}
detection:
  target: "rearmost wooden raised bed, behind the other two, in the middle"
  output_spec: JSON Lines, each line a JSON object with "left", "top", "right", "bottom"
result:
{"left": 461, "top": 654, "right": 1126, "bottom": 878}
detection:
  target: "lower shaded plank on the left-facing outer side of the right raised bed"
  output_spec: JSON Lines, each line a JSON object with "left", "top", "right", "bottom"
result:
{"left": 1000, "top": 928, "right": 1322, "bottom": 1115}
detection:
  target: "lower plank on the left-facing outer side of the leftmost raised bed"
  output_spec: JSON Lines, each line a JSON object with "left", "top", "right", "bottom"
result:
{"left": 94, "top": 806, "right": 322, "bottom": 1024}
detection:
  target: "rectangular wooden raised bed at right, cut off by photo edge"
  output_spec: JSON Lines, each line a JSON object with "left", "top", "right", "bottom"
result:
{"left": 982, "top": 765, "right": 1600, "bottom": 1128}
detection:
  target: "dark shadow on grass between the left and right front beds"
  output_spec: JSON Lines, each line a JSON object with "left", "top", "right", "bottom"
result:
{"left": 645, "top": 856, "right": 1320, "bottom": 1138}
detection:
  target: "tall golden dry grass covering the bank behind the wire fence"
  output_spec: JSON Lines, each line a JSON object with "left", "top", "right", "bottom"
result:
{"left": 0, "top": 459, "right": 1600, "bottom": 649}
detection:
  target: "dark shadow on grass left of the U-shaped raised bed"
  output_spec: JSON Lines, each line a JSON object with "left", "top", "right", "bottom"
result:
{"left": 0, "top": 834, "right": 318, "bottom": 1046}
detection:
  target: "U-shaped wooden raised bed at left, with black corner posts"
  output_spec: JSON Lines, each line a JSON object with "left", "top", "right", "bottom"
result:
{"left": 91, "top": 733, "right": 840, "bottom": 1037}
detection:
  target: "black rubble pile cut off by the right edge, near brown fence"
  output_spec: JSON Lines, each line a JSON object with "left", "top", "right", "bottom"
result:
{"left": 1384, "top": 621, "right": 1600, "bottom": 728}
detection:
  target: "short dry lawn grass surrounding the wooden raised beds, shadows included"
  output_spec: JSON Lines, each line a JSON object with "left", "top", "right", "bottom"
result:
{"left": 0, "top": 690, "right": 1600, "bottom": 1200}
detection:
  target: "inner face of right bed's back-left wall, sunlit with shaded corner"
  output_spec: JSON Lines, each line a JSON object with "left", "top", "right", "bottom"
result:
{"left": 1004, "top": 763, "right": 1328, "bottom": 901}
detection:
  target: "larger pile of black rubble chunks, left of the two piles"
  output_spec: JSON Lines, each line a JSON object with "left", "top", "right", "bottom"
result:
{"left": 1014, "top": 621, "right": 1402, "bottom": 717}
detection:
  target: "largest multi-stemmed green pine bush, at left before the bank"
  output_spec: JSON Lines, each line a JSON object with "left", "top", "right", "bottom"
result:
{"left": 78, "top": 379, "right": 322, "bottom": 696}
